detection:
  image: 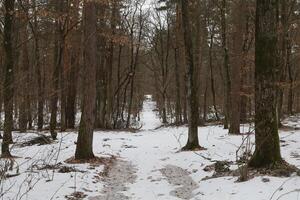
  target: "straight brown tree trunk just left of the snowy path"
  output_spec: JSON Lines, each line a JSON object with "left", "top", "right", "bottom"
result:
{"left": 75, "top": 0, "right": 97, "bottom": 159}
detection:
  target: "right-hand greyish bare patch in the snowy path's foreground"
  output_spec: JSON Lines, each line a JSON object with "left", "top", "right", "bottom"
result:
{"left": 160, "top": 165, "right": 198, "bottom": 199}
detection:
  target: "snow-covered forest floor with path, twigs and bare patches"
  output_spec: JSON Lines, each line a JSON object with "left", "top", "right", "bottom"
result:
{"left": 0, "top": 96, "right": 300, "bottom": 200}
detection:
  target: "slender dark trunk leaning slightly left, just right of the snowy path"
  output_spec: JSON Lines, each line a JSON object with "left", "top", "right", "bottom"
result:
{"left": 181, "top": 0, "right": 200, "bottom": 150}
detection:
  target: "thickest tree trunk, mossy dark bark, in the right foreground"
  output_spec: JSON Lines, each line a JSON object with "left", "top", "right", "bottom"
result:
{"left": 249, "top": 0, "right": 282, "bottom": 167}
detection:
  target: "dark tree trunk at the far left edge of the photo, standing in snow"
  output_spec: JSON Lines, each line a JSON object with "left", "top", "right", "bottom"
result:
{"left": 1, "top": 0, "right": 15, "bottom": 157}
